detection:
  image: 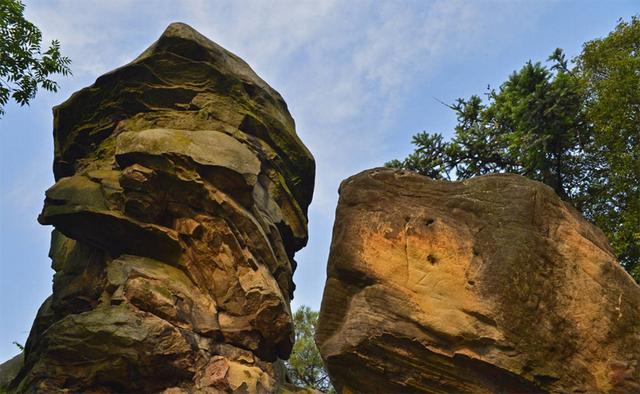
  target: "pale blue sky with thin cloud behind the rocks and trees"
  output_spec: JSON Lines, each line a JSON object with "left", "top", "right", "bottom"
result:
{"left": 0, "top": 0, "right": 640, "bottom": 361}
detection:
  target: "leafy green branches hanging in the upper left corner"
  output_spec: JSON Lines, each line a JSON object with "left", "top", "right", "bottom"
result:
{"left": 0, "top": 0, "right": 71, "bottom": 116}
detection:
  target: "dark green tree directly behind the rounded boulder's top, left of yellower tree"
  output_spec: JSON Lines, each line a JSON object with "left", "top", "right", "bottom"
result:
{"left": 387, "top": 54, "right": 588, "bottom": 198}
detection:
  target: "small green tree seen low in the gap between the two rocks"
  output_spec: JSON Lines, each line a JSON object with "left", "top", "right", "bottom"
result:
{"left": 286, "top": 305, "right": 335, "bottom": 393}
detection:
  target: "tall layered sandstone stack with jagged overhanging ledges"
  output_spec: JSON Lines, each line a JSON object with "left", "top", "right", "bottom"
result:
{"left": 11, "top": 23, "right": 315, "bottom": 393}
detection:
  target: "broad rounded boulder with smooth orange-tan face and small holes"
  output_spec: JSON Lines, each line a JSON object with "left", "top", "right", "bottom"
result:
{"left": 316, "top": 168, "right": 640, "bottom": 393}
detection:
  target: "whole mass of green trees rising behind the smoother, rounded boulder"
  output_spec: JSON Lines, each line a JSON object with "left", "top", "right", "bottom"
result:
{"left": 386, "top": 17, "right": 640, "bottom": 282}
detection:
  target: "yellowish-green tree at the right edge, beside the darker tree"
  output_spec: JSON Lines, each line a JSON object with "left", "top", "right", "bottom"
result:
{"left": 576, "top": 16, "right": 640, "bottom": 282}
